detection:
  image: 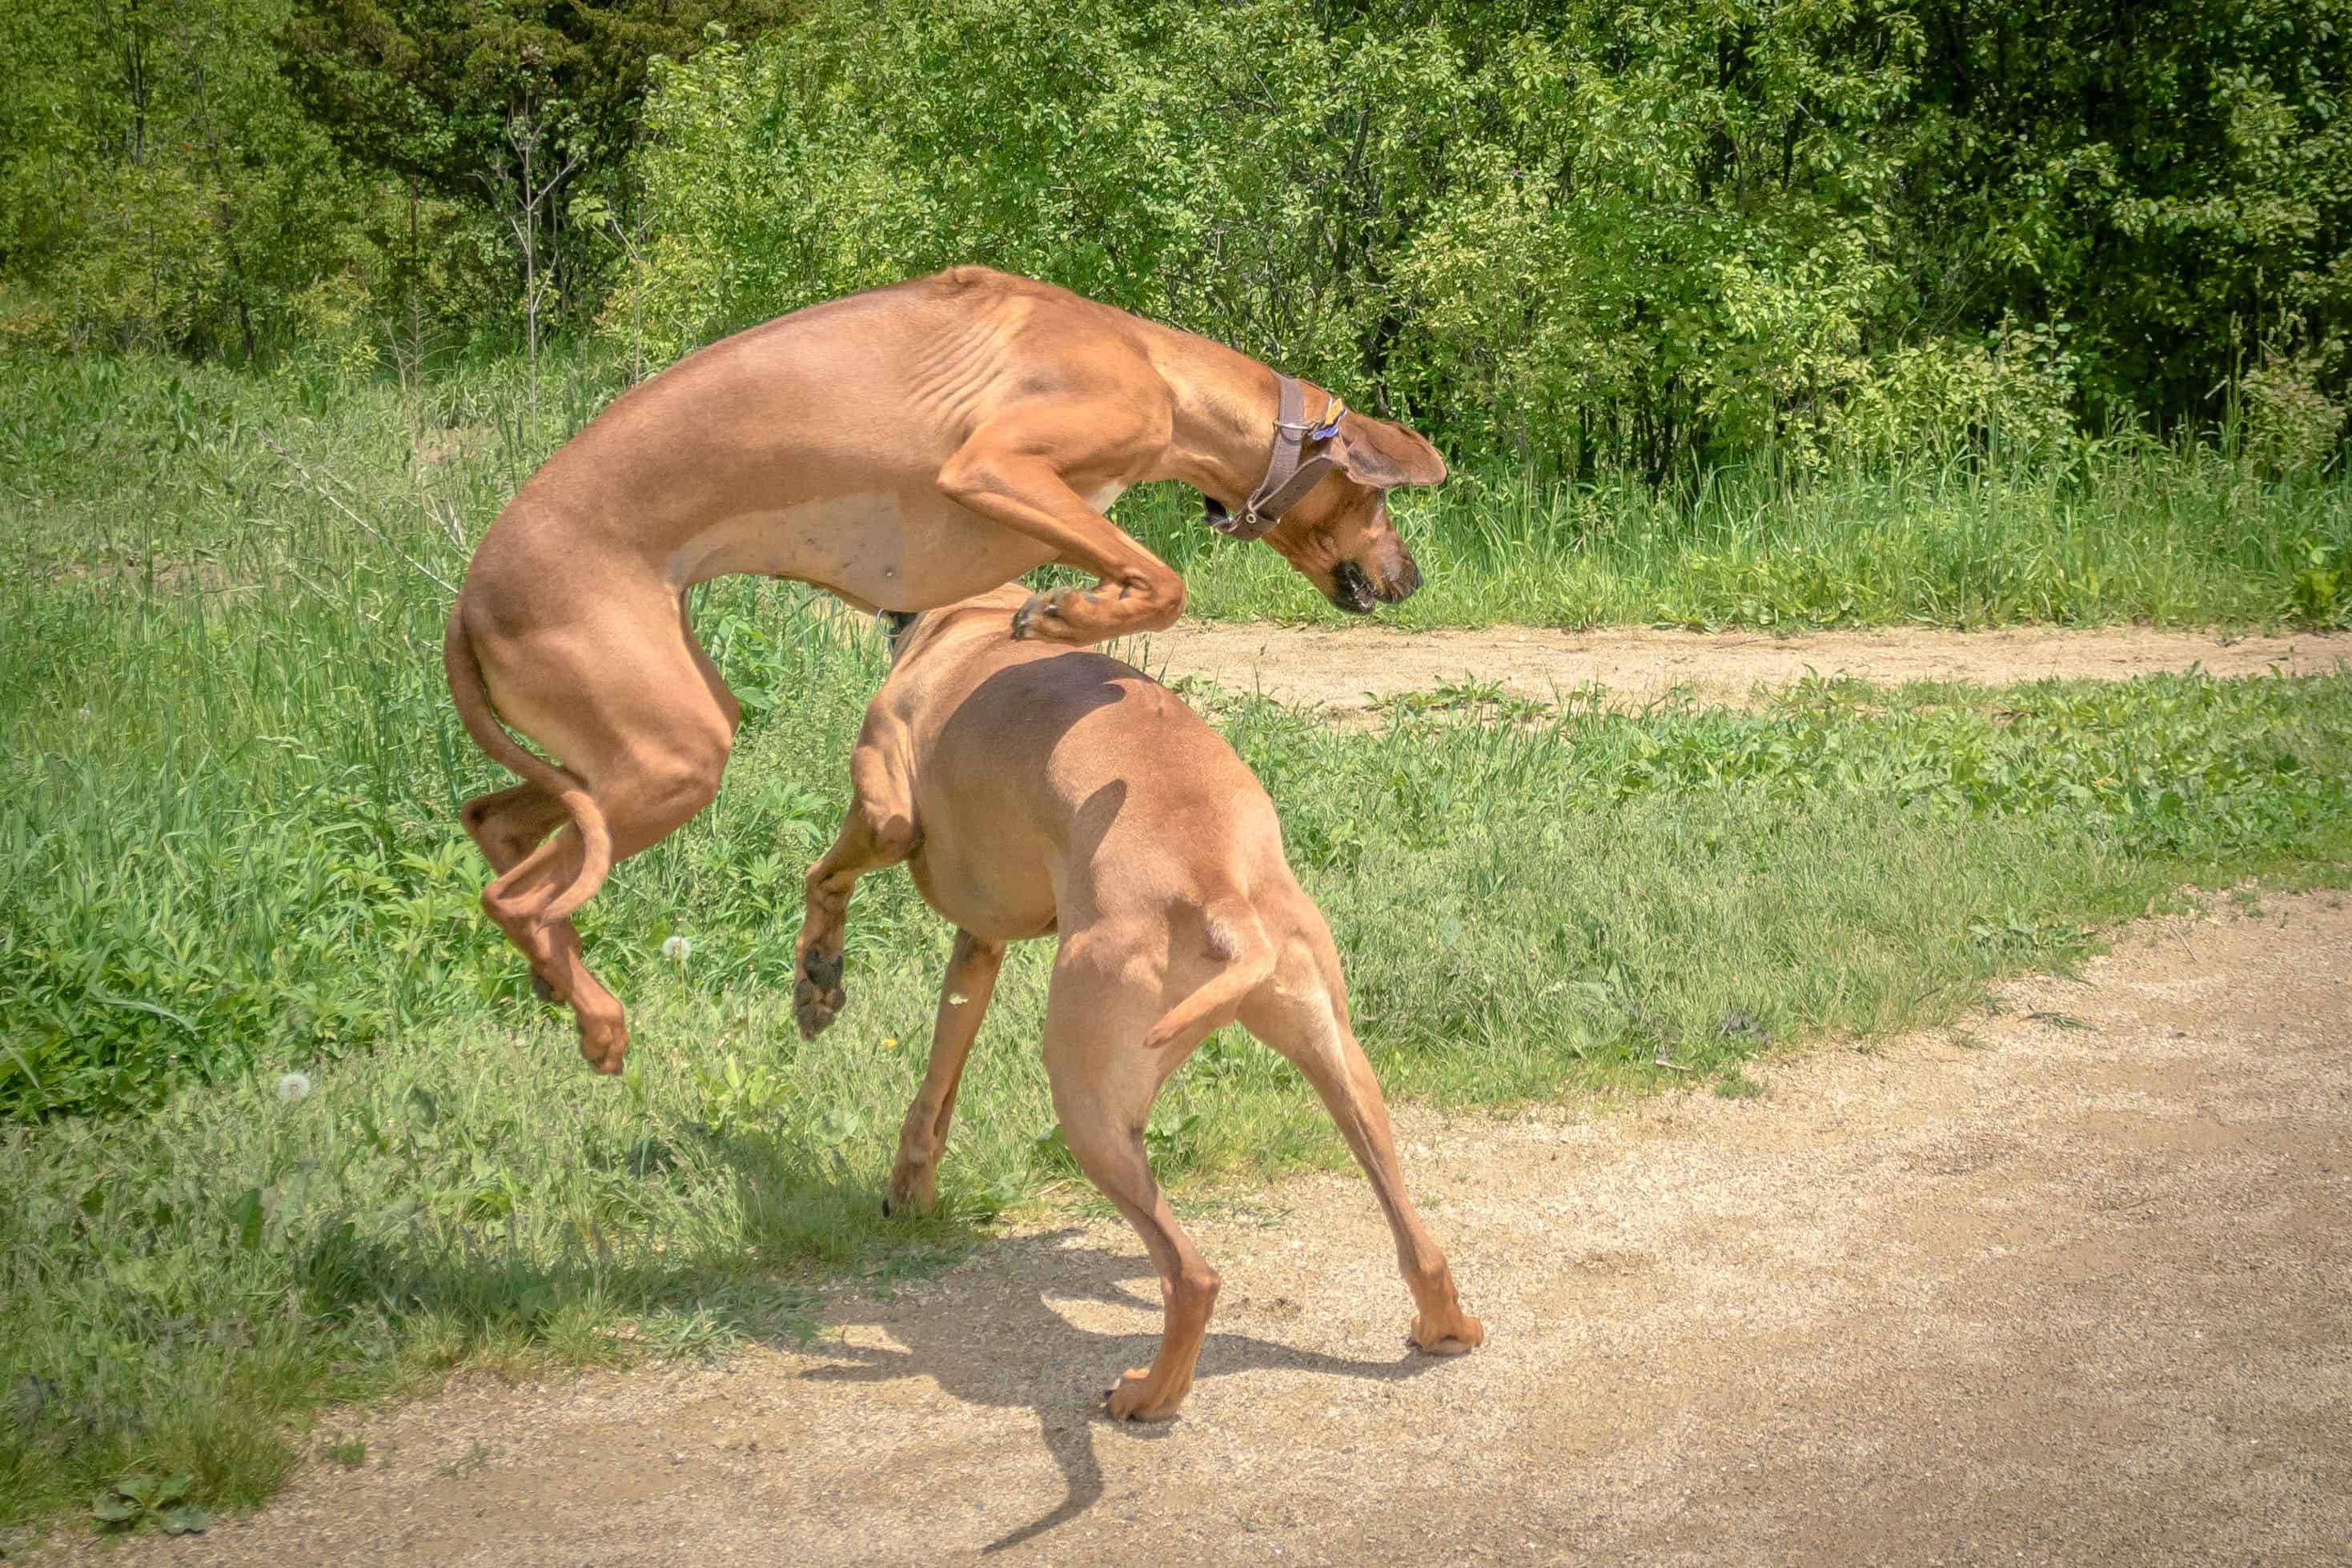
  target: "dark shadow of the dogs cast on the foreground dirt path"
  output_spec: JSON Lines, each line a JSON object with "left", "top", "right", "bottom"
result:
{"left": 785, "top": 1229, "right": 1437, "bottom": 1551}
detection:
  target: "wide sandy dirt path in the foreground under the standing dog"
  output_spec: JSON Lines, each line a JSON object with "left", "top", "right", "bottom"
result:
{"left": 68, "top": 893, "right": 2352, "bottom": 1566}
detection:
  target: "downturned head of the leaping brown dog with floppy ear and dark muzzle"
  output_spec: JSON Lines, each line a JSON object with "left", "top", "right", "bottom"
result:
{"left": 1266, "top": 409, "right": 1447, "bottom": 616}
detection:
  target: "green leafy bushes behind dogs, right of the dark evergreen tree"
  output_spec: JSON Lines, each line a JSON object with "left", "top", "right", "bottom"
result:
{"left": 625, "top": 0, "right": 2352, "bottom": 477}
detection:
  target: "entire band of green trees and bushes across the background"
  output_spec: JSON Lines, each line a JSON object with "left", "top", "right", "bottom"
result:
{"left": 0, "top": 0, "right": 2352, "bottom": 465}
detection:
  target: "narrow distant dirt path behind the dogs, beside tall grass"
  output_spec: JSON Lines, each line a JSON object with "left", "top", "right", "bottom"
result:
{"left": 1122, "top": 620, "right": 2352, "bottom": 710}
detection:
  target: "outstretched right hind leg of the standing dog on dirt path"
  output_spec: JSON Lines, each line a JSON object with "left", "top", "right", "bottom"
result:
{"left": 1242, "top": 931, "right": 1487, "bottom": 1357}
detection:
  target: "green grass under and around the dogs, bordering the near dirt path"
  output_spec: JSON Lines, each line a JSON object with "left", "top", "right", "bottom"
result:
{"left": 14, "top": 345, "right": 2352, "bottom": 1521}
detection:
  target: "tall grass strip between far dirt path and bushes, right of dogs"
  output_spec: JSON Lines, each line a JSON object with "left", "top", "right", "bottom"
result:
{"left": 1119, "top": 439, "right": 2352, "bottom": 630}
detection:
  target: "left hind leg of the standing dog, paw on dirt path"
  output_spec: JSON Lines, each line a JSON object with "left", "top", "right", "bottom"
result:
{"left": 1044, "top": 938, "right": 1218, "bottom": 1420}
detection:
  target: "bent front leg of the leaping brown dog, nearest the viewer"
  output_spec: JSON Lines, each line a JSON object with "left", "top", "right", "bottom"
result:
{"left": 938, "top": 421, "right": 1183, "bottom": 647}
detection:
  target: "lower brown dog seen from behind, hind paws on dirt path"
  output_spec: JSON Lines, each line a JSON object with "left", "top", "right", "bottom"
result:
{"left": 795, "top": 587, "right": 1487, "bottom": 1420}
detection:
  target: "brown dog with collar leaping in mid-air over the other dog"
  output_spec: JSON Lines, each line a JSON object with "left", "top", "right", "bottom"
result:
{"left": 444, "top": 268, "right": 1447, "bottom": 1072}
